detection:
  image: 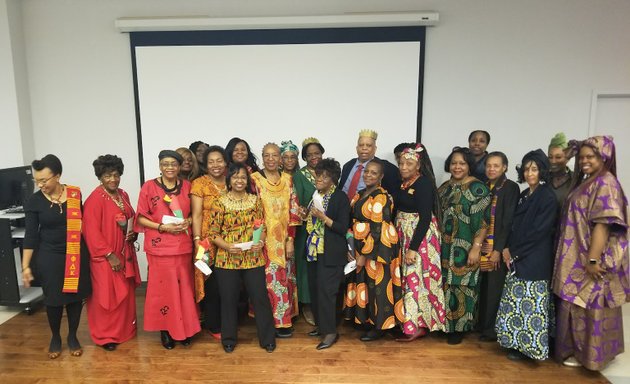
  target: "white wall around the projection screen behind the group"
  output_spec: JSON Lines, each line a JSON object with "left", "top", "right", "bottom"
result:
{"left": 13, "top": 0, "right": 630, "bottom": 276}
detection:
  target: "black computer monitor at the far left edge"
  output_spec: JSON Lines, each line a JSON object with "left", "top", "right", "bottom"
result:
{"left": 0, "top": 165, "right": 35, "bottom": 209}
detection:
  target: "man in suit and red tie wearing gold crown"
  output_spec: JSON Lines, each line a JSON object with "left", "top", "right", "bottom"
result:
{"left": 339, "top": 129, "right": 401, "bottom": 199}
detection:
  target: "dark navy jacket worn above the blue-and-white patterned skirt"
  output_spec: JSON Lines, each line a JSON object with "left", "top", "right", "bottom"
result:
{"left": 508, "top": 184, "right": 557, "bottom": 281}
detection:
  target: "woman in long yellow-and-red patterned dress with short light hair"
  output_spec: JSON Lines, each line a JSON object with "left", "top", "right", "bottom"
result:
{"left": 252, "top": 143, "right": 301, "bottom": 338}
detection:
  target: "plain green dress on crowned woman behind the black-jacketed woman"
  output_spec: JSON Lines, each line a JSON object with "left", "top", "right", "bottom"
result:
{"left": 293, "top": 166, "right": 315, "bottom": 304}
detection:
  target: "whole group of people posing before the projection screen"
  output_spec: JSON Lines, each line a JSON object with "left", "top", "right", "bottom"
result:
{"left": 23, "top": 130, "right": 630, "bottom": 370}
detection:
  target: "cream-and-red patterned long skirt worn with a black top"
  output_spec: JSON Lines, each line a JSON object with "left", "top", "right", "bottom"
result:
{"left": 396, "top": 212, "right": 446, "bottom": 335}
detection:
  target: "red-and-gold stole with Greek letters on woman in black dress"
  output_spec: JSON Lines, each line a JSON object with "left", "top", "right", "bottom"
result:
{"left": 61, "top": 185, "right": 81, "bottom": 293}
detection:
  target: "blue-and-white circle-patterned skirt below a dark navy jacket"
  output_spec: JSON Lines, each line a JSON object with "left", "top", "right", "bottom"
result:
{"left": 495, "top": 276, "right": 553, "bottom": 360}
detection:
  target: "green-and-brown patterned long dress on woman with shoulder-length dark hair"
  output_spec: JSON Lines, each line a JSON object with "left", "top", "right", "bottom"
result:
{"left": 438, "top": 179, "right": 491, "bottom": 333}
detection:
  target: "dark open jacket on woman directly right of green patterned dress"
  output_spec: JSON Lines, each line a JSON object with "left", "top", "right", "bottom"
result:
{"left": 490, "top": 176, "right": 521, "bottom": 253}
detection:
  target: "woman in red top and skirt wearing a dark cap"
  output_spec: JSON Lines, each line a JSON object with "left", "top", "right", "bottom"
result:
{"left": 135, "top": 150, "right": 201, "bottom": 349}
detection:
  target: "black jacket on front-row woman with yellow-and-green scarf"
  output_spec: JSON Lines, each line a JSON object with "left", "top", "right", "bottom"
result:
{"left": 324, "top": 188, "right": 350, "bottom": 267}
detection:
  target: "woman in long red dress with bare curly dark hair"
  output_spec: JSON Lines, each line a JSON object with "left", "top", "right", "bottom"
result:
{"left": 83, "top": 155, "right": 140, "bottom": 351}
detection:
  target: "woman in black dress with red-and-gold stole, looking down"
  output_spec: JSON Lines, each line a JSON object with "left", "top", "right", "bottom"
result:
{"left": 22, "top": 155, "right": 91, "bottom": 359}
